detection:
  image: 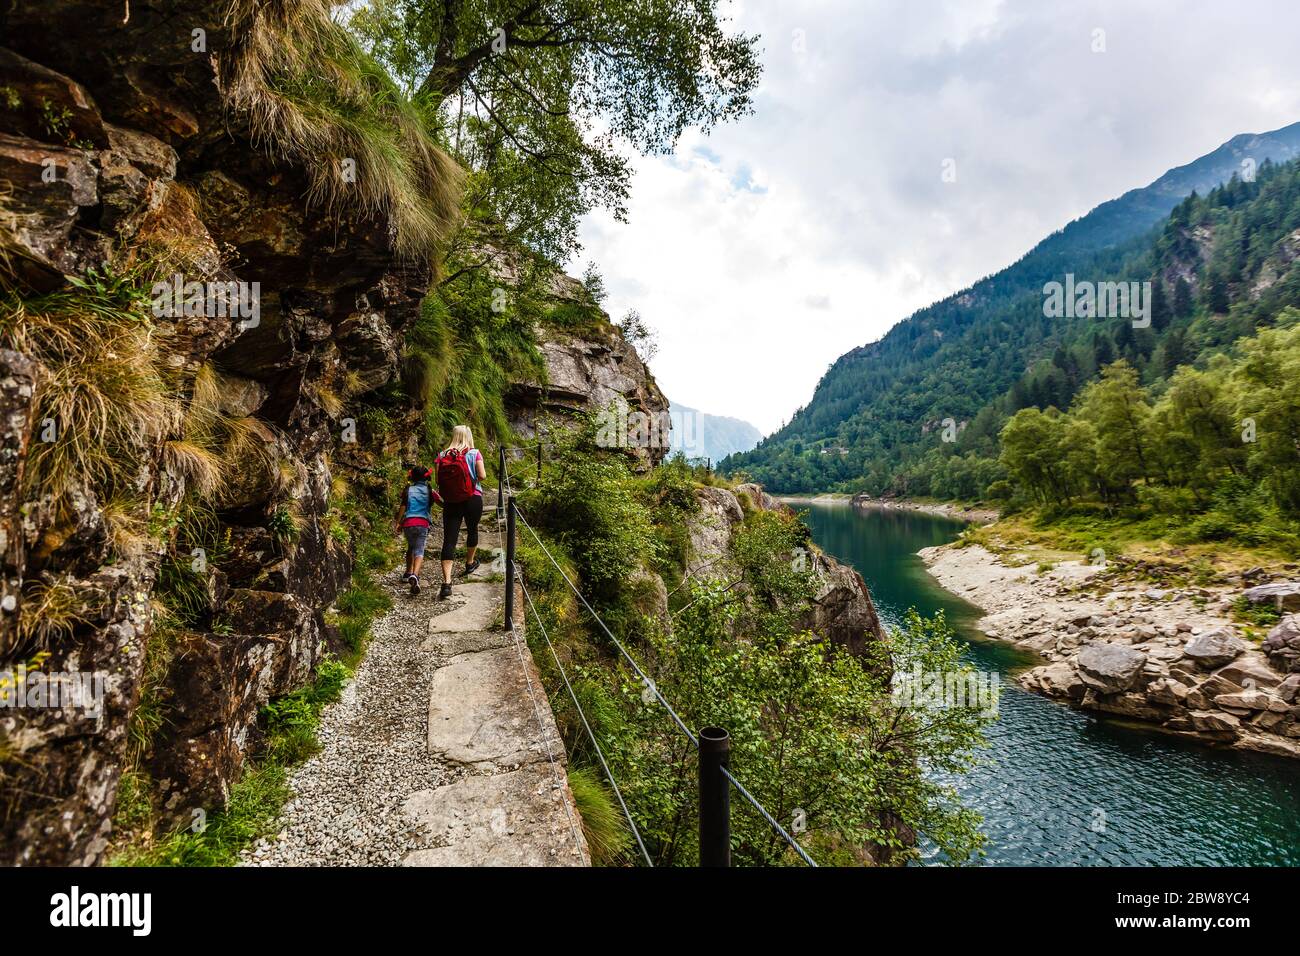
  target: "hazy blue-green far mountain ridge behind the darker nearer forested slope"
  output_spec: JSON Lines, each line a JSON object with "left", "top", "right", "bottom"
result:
{"left": 723, "top": 122, "right": 1300, "bottom": 493}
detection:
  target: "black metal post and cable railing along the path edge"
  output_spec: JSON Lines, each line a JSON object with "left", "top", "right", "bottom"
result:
{"left": 497, "top": 446, "right": 818, "bottom": 866}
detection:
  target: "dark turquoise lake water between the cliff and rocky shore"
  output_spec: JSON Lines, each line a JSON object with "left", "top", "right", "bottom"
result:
{"left": 798, "top": 506, "right": 1300, "bottom": 866}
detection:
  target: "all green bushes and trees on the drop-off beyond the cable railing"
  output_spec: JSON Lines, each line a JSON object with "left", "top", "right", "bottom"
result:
{"left": 519, "top": 427, "right": 987, "bottom": 866}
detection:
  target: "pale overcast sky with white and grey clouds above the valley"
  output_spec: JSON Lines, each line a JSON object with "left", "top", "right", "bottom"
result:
{"left": 571, "top": 0, "right": 1300, "bottom": 433}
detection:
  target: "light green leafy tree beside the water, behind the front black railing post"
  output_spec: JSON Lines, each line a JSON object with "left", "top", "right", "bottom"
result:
{"left": 615, "top": 582, "right": 988, "bottom": 865}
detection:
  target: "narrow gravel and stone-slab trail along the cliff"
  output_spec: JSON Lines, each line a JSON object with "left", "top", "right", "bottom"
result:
{"left": 243, "top": 520, "right": 590, "bottom": 866}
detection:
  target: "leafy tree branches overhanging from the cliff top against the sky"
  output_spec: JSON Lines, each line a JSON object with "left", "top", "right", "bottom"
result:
{"left": 347, "top": 0, "right": 761, "bottom": 261}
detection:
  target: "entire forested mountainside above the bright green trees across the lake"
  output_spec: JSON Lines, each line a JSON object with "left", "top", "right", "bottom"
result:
{"left": 724, "top": 125, "right": 1300, "bottom": 497}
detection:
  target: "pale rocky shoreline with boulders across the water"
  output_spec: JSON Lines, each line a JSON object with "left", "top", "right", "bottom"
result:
{"left": 919, "top": 545, "right": 1300, "bottom": 757}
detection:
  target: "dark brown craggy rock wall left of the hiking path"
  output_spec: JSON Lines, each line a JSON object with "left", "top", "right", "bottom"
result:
{"left": 0, "top": 0, "right": 428, "bottom": 864}
